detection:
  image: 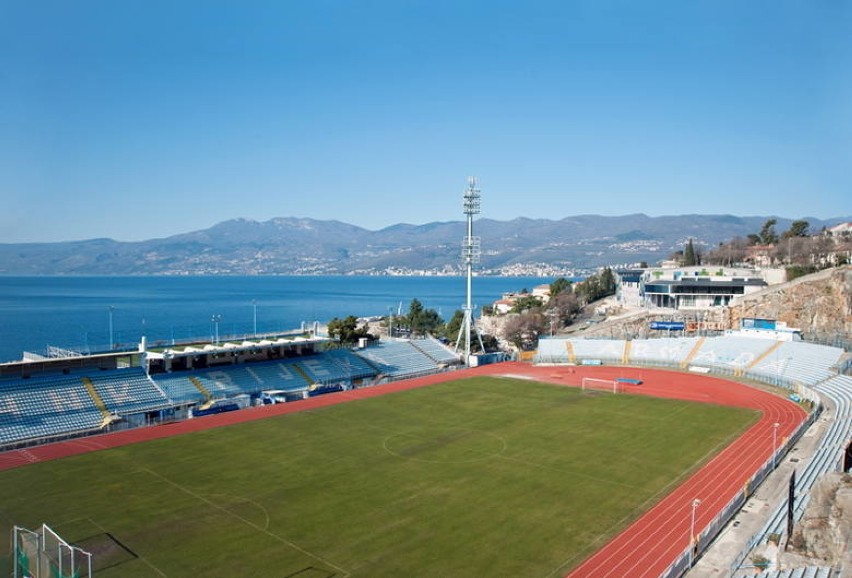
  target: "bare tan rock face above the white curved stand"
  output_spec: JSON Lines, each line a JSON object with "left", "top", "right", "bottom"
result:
{"left": 727, "top": 265, "right": 852, "bottom": 341}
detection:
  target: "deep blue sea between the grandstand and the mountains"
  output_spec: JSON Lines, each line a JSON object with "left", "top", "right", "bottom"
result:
{"left": 0, "top": 276, "right": 554, "bottom": 362}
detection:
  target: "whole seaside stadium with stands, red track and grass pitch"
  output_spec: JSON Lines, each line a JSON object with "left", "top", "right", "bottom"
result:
{"left": 0, "top": 322, "right": 852, "bottom": 577}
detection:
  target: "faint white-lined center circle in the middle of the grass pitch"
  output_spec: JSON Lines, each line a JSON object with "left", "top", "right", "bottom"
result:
{"left": 384, "top": 428, "right": 507, "bottom": 464}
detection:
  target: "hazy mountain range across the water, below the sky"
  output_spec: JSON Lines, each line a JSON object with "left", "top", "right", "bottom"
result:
{"left": 0, "top": 214, "right": 852, "bottom": 275}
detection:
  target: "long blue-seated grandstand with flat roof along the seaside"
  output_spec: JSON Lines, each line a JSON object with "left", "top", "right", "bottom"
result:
{"left": 0, "top": 338, "right": 459, "bottom": 450}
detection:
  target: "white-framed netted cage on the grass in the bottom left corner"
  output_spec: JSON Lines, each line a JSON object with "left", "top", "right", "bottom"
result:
{"left": 12, "top": 524, "right": 92, "bottom": 578}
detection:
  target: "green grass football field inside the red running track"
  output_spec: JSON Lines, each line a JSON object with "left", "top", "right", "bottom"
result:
{"left": 0, "top": 378, "right": 757, "bottom": 578}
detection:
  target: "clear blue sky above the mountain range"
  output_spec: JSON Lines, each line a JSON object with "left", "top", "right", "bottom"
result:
{"left": 0, "top": 0, "right": 852, "bottom": 242}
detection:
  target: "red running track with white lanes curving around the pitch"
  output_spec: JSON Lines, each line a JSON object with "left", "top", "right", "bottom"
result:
{"left": 0, "top": 363, "right": 806, "bottom": 578}
